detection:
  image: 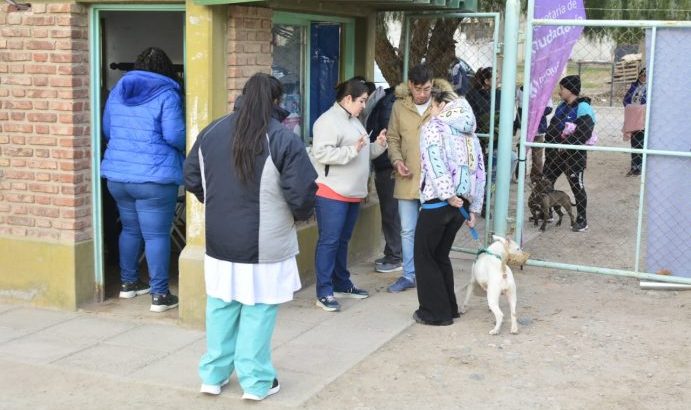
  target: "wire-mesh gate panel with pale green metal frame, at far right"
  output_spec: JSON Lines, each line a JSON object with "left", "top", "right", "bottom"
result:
{"left": 512, "top": 1, "right": 691, "bottom": 284}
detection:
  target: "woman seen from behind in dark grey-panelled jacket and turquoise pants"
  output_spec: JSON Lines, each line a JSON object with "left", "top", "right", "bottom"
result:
{"left": 185, "top": 73, "right": 317, "bottom": 400}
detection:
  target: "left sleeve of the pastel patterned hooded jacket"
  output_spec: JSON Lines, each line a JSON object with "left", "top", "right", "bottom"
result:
{"left": 420, "top": 121, "right": 455, "bottom": 201}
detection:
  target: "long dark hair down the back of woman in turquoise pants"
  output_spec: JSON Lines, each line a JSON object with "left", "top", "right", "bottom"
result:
{"left": 233, "top": 73, "right": 283, "bottom": 184}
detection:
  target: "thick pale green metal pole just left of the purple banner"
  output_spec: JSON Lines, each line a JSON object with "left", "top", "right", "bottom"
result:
{"left": 489, "top": 0, "right": 520, "bottom": 236}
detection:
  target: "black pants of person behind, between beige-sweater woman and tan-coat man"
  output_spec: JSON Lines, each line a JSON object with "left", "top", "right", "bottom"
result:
{"left": 374, "top": 169, "right": 401, "bottom": 261}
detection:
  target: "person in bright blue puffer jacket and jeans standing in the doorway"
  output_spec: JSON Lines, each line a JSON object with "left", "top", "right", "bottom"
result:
{"left": 101, "top": 47, "right": 185, "bottom": 312}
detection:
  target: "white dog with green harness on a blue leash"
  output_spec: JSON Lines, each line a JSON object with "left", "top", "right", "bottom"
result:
{"left": 460, "top": 235, "right": 529, "bottom": 335}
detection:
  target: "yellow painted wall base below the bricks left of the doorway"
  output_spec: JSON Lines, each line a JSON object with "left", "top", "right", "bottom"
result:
{"left": 0, "top": 238, "right": 97, "bottom": 310}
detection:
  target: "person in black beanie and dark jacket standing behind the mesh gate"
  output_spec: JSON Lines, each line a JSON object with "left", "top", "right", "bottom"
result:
{"left": 543, "top": 75, "right": 596, "bottom": 232}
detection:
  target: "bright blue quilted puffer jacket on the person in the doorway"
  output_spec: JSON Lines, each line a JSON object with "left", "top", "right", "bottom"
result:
{"left": 101, "top": 70, "right": 185, "bottom": 185}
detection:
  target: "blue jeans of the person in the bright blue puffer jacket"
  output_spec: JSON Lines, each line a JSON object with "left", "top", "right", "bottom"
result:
{"left": 108, "top": 181, "right": 178, "bottom": 294}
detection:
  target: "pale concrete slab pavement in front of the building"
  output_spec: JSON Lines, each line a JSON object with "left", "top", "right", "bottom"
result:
{"left": 0, "top": 258, "right": 474, "bottom": 409}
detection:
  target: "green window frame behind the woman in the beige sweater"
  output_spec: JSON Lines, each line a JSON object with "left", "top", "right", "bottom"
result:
{"left": 272, "top": 11, "right": 355, "bottom": 141}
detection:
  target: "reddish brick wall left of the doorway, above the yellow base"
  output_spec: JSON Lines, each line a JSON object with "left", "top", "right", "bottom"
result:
{"left": 0, "top": 3, "right": 92, "bottom": 241}
